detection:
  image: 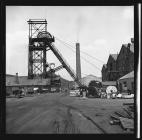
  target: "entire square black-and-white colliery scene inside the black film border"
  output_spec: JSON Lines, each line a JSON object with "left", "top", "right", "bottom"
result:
{"left": 1, "top": 5, "right": 140, "bottom": 135}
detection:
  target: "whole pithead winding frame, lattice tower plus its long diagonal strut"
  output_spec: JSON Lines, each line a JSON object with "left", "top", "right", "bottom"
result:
{"left": 28, "top": 19, "right": 82, "bottom": 86}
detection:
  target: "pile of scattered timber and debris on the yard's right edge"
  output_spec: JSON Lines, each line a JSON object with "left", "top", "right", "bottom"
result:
{"left": 110, "top": 103, "right": 134, "bottom": 132}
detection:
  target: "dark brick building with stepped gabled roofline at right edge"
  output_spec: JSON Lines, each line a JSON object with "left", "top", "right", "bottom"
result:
{"left": 102, "top": 38, "right": 134, "bottom": 81}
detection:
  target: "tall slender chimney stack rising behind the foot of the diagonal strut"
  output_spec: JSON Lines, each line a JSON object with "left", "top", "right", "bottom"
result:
{"left": 76, "top": 43, "right": 81, "bottom": 80}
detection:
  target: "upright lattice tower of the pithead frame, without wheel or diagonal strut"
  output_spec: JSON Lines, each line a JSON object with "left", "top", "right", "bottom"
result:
{"left": 28, "top": 19, "right": 47, "bottom": 79}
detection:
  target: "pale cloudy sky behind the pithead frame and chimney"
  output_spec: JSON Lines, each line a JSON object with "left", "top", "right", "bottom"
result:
{"left": 6, "top": 6, "right": 134, "bottom": 80}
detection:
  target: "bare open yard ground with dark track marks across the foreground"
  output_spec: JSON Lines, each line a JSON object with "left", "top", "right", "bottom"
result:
{"left": 6, "top": 93, "right": 133, "bottom": 134}
